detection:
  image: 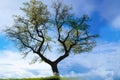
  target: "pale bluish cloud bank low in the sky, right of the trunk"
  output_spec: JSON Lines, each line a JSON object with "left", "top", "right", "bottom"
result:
{"left": 60, "top": 42, "right": 120, "bottom": 80}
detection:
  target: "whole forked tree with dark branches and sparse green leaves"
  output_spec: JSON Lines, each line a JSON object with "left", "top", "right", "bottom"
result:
{"left": 5, "top": 0, "right": 96, "bottom": 76}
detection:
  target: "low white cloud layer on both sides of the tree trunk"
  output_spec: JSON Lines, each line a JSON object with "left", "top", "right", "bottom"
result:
{"left": 0, "top": 42, "right": 120, "bottom": 80}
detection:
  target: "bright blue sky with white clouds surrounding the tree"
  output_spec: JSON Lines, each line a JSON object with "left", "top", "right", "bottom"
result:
{"left": 0, "top": 0, "right": 120, "bottom": 80}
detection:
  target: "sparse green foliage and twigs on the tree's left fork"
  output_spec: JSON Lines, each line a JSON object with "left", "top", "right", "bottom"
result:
{"left": 5, "top": 0, "right": 50, "bottom": 56}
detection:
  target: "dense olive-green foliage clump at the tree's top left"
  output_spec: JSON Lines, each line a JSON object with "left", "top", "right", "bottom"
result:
{"left": 21, "top": 0, "right": 49, "bottom": 24}
